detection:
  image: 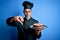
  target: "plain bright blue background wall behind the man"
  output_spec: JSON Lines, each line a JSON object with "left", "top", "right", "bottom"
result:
{"left": 0, "top": 0, "right": 60, "bottom": 40}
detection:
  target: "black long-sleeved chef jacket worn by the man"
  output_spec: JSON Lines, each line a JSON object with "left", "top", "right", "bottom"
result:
{"left": 6, "top": 17, "right": 41, "bottom": 40}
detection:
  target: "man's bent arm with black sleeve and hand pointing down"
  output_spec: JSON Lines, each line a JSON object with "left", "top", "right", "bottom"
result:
{"left": 6, "top": 16, "right": 24, "bottom": 26}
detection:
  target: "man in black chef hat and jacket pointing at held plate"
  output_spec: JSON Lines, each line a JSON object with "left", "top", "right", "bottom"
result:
{"left": 6, "top": 1, "right": 44, "bottom": 40}
